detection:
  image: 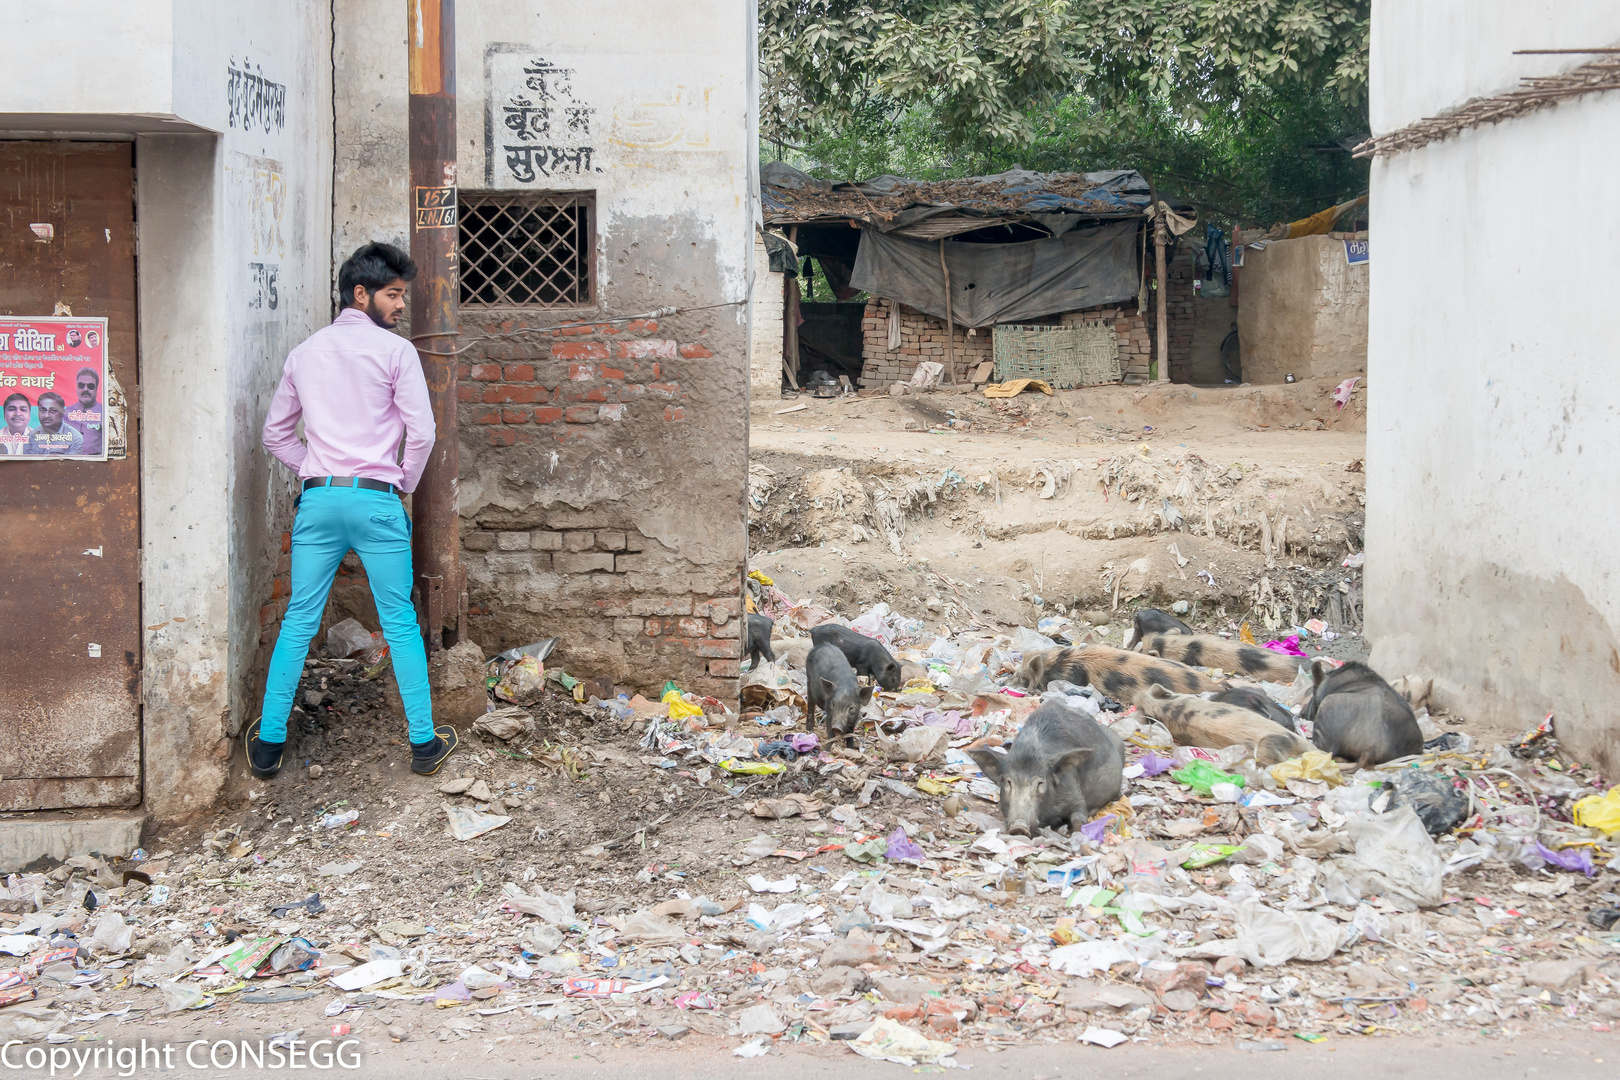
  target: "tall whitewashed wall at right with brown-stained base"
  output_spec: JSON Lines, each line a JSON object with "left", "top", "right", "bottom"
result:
{"left": 1367, "top": 0, "right": 1620, "bottom": 776}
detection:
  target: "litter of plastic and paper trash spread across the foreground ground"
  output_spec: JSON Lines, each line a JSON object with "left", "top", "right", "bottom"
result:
{"left": 0, "top": 586, "right": 1620, "bottom": 1067}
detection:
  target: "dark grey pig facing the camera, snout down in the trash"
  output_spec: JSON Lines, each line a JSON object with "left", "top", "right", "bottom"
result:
{"left": 967, "top": 701, "right": 1124, "bottom": 836}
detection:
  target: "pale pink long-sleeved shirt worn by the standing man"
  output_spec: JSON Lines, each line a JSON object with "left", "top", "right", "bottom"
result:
{"left": 264, "top": 308, "right": 434, "bottom": 491}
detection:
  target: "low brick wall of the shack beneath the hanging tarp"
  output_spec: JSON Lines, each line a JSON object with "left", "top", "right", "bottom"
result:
{"left": 860, "top": 299, "right": 1146, "bottom": 387}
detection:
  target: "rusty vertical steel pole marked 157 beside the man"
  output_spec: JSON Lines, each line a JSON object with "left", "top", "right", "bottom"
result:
{"left": 405, "top": 0, "right": 467, "bottom": 653}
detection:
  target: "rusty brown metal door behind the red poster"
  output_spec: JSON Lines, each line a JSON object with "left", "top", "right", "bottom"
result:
{"left": 0, "top": 141, "right": 141, "bottom": 810}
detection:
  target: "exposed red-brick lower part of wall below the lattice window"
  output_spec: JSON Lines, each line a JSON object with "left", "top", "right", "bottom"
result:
{"left": 457, "top": 308, "right": 748, "bottom": 696}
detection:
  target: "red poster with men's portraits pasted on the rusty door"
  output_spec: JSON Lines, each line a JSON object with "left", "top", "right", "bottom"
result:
{"left": 0, "top": 317, "right": 109, "bottom": 461}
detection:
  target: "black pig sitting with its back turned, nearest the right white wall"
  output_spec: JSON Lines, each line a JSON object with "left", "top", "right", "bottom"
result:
{"left": 1304, "top": 661, "right": 1422, "bottom": 769}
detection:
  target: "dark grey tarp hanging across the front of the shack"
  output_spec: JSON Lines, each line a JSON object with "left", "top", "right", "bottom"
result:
{"left": 849, "top": 222, "right": 1140, "bottom": 327}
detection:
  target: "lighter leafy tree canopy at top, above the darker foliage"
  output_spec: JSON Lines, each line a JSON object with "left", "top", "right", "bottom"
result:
{"left": 760, "top": 0, "right": 1371, "bottom": 144}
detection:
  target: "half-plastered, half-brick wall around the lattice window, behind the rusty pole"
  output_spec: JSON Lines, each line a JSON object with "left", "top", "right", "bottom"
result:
{"left": 334, "top": 0, "right": 757, "bottom": 691}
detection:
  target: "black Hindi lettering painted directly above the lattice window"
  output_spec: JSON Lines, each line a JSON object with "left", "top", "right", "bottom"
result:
{"left": 486, "top": 57, "right": 601, "bottom": 185}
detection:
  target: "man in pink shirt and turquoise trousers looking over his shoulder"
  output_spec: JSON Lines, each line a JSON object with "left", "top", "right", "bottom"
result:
{"left": 243, "top": 243, "right": 455, "bottom": 779}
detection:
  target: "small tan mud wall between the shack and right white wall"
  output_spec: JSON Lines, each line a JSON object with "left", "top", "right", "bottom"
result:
{"left": 1238, "top": 233, "right": 1369, "bottom": 384}
